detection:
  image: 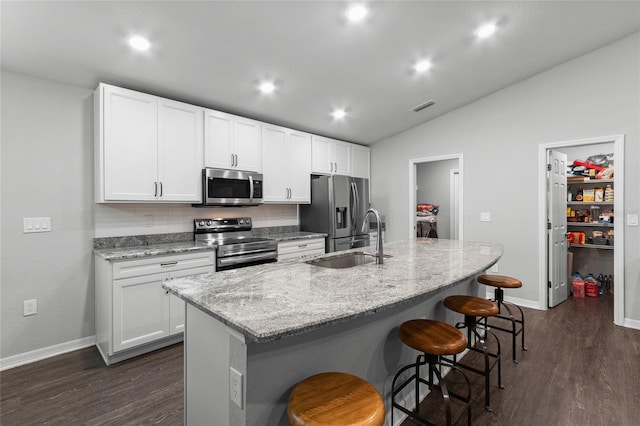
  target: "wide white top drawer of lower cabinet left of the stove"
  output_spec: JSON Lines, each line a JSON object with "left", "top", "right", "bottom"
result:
{"left": 113, "top": 251, "right": 216, "bottom": 280}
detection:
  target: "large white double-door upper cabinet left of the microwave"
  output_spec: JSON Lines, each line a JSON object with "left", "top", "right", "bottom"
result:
{"left": 94, "top": 84, "right": 203, "bottom": 203}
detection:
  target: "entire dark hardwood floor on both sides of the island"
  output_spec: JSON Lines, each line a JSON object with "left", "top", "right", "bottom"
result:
{"left": 0, "top": 296, "right": 640, "bottom": 426}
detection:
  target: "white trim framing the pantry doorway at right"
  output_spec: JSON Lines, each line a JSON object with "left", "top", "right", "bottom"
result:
{"left": 538, "top": 135, "right": 624, "bottom": 328}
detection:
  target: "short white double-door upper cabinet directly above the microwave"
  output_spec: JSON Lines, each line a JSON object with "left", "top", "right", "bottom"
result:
{"left": 204, "top": 110, "right": 262, "bottom": 172}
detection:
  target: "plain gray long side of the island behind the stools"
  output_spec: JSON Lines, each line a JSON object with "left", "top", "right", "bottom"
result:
{"left": 246, "top": 278, "right": 479, "bottom": 426}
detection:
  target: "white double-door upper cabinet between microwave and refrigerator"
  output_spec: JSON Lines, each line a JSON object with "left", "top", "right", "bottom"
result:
{"left": 262, "top": 123, "right": 311, "bottom": 204}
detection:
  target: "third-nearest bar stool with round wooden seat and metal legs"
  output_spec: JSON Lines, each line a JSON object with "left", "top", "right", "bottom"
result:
{"left": 443, "top": 295, "right": 504, "bottom": 411}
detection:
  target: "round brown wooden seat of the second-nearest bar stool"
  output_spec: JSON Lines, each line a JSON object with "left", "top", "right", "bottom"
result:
{"left": 398, "top": 319, "right": 467, "bottom": 355}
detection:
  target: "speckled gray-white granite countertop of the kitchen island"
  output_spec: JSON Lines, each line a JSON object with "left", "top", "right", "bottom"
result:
{"left": 163, "top": 239, "right": 502, "bottom": 343}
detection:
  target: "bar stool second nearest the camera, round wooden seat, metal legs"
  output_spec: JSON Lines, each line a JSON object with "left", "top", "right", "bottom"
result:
{"left": 391, "top": 319, "right": 471, "bottom": 425}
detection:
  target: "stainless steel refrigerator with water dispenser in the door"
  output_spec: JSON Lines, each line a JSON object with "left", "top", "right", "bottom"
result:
{"left": 300, "top": 175, "right": 369, "bottom": 252}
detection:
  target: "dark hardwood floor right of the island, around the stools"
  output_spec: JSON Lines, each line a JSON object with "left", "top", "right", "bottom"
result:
{"left": 403, "top": 295, "right": 640, "bottom": 426}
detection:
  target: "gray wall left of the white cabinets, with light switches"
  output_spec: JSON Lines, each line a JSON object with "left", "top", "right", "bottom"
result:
{"left": 0, "top": 72, "right": 95, "bottom": 358}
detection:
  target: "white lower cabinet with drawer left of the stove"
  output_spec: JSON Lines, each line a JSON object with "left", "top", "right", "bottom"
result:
{"left": 96, "top": 251, "right": 215, "bottom": 365}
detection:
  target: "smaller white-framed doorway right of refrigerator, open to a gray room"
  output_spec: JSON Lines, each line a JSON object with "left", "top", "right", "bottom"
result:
{"left": 409, "top": 154, "right": 463, "bottom": 240}
